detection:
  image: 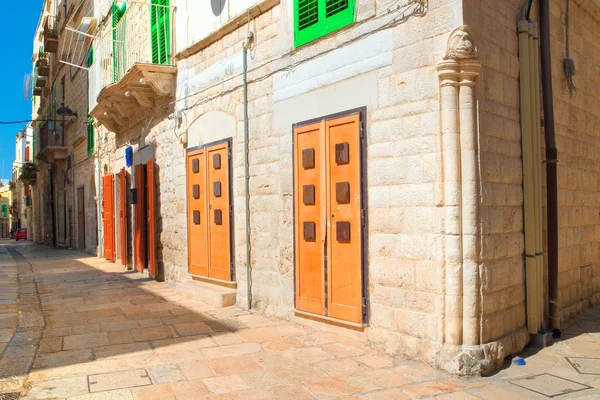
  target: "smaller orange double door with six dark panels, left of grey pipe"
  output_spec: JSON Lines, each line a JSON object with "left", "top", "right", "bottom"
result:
{"left": 186, "top": 141, "right": 233, "bottom": 281}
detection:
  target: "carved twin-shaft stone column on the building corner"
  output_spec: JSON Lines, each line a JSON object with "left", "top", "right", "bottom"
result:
{"left": 437, "top": 26, "right": 488, "bottom": 374}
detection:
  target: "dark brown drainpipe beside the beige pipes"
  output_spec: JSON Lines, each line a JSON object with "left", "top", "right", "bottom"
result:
{"left": 539, "top": 0, "right": 560, "bottom": 336}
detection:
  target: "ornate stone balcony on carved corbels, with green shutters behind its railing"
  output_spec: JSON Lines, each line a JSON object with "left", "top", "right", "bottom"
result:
{"left": 88, "top": 0, "right": 177, "bottom": 133}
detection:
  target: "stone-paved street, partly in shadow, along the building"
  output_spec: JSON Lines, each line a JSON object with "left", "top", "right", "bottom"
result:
{"left": 0, "top": 241, "right": 600, "bottom": 400}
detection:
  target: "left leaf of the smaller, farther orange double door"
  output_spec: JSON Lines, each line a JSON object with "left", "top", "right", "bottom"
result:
{"left": 186, "top": 149, "right": 208, "bottom": 277}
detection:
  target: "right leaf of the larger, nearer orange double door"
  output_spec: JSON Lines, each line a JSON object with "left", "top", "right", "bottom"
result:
{"left": 325, "top": 114, "right": 363, "bottom": 323}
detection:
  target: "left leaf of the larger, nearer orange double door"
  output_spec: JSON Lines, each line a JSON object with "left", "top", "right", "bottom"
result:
{"left": 294, "top": 123, "right": 326, "bottom": 315}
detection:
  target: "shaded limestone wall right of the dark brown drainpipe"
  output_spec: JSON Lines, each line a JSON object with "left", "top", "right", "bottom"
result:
{"left": 550, "top": 0, "right": 600, "bottom": 321}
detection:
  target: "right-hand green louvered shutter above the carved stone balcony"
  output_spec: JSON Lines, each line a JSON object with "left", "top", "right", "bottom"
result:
{"left": 150, "top": 0, "right": 171, "bottom": 65}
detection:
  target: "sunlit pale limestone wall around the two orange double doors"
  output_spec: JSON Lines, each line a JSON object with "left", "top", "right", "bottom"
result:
{"left": 166, "top": 1, "right": 462, "bottom": 358}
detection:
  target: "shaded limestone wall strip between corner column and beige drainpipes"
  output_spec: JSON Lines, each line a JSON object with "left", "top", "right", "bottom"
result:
{"left": 463, "top": 0, "right": 526, "bottom": 343}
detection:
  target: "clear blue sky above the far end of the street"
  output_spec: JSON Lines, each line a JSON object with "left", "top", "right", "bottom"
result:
{"left": 0, "top": 0, "right": 42, "bottom": 179}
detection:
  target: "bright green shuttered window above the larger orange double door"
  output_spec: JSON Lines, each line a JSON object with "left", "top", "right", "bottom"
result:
{"left": 294, "top": 0, "right": 356, "bottom": 47}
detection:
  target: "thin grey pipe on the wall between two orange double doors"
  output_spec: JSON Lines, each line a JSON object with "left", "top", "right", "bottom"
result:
{"left": 242, "top": 31, "right": 253, "bottom": 310}
